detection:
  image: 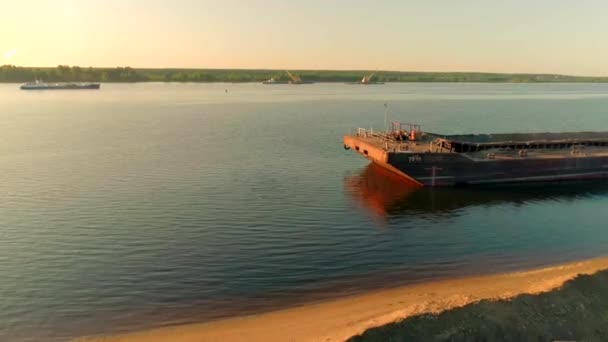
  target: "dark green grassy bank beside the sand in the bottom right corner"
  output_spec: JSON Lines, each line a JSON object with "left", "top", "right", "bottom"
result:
{"left": 350, "top": 271, "right": 608, "bottom": 342}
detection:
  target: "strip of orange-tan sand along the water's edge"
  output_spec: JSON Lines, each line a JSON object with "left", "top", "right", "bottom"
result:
{"left": 78, "top": 257, "right": 608, "bottom": 342}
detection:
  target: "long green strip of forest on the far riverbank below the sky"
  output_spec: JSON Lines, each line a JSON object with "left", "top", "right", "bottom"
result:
{"left": 0, "top": 65, "right": 608, "bottom": 83}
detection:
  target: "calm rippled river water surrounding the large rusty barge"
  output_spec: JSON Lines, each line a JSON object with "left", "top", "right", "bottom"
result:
{"left": 0, "top": 84, "right": 608, "bottom": 341}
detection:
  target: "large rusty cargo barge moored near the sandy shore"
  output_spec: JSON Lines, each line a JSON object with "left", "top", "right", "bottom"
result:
{"left": 344, "top": 122, "right": 608, "bottom": 186}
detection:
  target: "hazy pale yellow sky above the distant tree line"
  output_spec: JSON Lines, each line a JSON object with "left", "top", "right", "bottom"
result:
{"left": 0, "top": 0, "right": 608, "bottom": 75}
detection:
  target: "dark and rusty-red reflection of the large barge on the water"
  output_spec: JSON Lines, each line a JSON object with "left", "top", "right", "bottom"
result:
{"left": 344, "top": 163, "right": 608, "bottom": 218}
